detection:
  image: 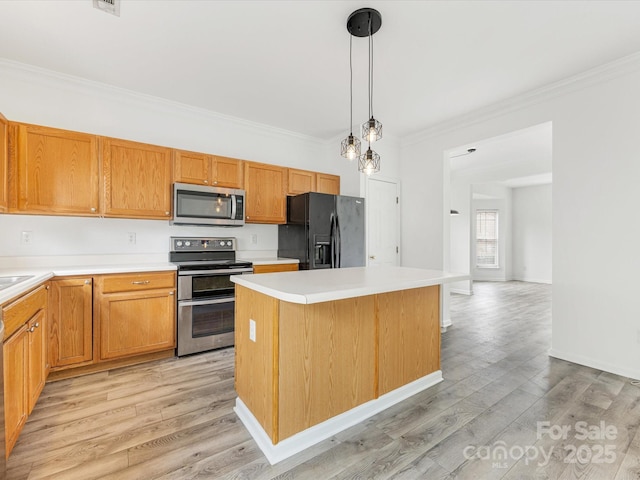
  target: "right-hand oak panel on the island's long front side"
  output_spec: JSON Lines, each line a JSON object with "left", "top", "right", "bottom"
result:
{"left": 376, "top": 285, "right": 440, "bottom": 395}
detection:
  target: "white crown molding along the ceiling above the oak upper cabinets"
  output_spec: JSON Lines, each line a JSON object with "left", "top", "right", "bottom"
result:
{"left": 0, "top": 58, "right": 325, "bottom": 145}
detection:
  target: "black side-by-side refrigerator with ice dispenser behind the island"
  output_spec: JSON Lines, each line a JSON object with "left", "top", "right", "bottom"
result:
{"left": 278, "top": 193, "right": 365, "bottom": 270}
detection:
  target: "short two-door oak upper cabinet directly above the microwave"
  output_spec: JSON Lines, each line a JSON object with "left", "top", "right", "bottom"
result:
{"left": 173, "top": 150, "right": 244, "bottom": 188}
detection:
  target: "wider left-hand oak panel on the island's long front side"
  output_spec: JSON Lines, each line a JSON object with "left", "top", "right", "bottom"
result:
{"left": 279, "top": 295, "right": 377, "bottom": 440}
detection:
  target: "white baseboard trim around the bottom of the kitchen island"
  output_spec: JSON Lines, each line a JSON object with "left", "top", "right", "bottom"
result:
{"left": 233, "top": 370, "right": 443, "bottom": 465}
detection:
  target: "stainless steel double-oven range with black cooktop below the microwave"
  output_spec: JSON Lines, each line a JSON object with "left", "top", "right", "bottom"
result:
{"left": 169, "top": 237, "right": 253, "bottom": 356}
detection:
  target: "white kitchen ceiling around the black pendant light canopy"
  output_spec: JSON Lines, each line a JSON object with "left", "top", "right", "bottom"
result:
{"left": 0, "top": 0, "right": 640, "bottom": 140}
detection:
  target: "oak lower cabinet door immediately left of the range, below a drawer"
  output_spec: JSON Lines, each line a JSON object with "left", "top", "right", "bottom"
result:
{"left": 99, "top": 290, "right": 176, "bottom": 360}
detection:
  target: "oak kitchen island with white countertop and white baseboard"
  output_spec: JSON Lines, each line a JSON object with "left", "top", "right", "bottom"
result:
{"left": 232, "top": 267, "right": 467, "bottom": 464}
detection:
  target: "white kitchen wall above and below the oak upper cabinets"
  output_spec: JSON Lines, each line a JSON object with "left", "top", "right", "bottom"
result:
{"left": 0, "top": 60, "right": 399, "bottom": 267}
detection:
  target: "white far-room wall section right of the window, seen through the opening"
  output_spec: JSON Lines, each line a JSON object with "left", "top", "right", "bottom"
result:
{"left": 512, "top": 184, "right": 552, "bottom": 283}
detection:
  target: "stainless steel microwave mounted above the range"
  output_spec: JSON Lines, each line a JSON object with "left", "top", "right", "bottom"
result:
{"left": 171, "top": 183, "right": 245, "bottom": 226}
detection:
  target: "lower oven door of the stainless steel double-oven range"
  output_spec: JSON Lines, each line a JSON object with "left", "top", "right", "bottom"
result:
{"left": 178, "top": 296, "right": 235, "bottom": 356}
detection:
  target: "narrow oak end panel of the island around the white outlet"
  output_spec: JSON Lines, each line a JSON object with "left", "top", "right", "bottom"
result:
{"left": 235, "top": 285, "right": 278, "bottom": 444}
